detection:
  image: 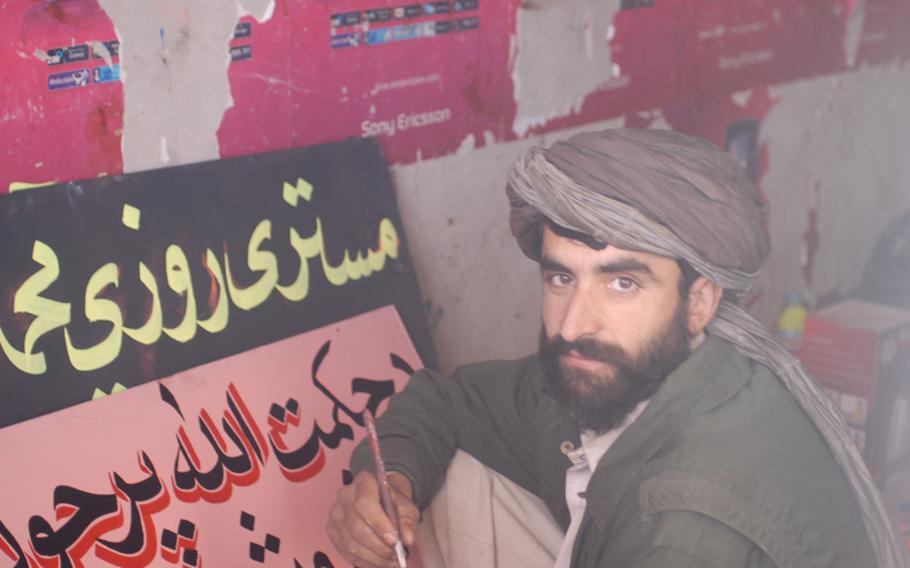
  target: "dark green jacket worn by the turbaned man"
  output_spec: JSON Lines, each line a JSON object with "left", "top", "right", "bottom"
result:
{"left": 352, "top": 337, "right": 875, "bottom": 568}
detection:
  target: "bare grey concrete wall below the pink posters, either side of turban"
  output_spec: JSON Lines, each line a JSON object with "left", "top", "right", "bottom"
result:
{"left": 395, "top": 65, "right": 910, "bottom": 369}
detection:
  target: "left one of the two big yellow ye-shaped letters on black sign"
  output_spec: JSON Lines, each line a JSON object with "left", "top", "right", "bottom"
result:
{"left": 63, "top": 262, "right": 123, "bottom": 371}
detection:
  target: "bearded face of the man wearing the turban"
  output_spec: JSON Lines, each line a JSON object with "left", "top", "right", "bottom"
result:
{"left": 540, "top": 227, "right": 689, "bottom": 432}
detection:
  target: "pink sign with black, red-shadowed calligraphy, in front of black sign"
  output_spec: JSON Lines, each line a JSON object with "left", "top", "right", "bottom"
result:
{"left": 0, "top": 306, "right": 422, "bottom": 568}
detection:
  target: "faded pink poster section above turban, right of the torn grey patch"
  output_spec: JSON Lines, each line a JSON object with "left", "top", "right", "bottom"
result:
{"left": 534, "top": 0, "right": 864, "bottom": 132}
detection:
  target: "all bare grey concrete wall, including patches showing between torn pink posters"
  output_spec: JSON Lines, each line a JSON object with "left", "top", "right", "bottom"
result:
{"left": 75, "top": 0, "right": 910, "bottom": 370}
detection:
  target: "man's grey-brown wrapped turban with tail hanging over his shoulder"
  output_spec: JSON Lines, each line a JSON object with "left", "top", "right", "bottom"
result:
{"left": 506, "top": 129, "right": 905, "bottom": 568}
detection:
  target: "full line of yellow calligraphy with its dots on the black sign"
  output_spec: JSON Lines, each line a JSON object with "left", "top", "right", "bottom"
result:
{"left": 0, "top": 178, "right": 401, "bottom": 375}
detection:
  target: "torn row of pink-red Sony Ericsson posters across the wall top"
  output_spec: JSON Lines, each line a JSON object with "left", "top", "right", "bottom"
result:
{"left": 0, "top": 0, "right": 910, "bottom": 192}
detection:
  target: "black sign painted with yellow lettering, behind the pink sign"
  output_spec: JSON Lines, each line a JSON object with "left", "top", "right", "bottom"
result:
{"left": 0, "top": 139, "right": 432, "bottom": 426}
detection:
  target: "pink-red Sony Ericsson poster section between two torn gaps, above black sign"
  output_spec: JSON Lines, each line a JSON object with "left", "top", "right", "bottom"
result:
{"left": 218, "top": 0, "right": 518, "bottom": 166}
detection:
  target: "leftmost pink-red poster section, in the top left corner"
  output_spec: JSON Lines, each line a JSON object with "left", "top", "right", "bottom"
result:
{"left": 0, "top": 0, "right": 123, "bottom": 193}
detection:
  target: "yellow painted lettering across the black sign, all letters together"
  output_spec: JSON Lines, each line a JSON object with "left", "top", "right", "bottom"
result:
{"left": 0, "top": 191, "right": 401, "bottom": 375}
